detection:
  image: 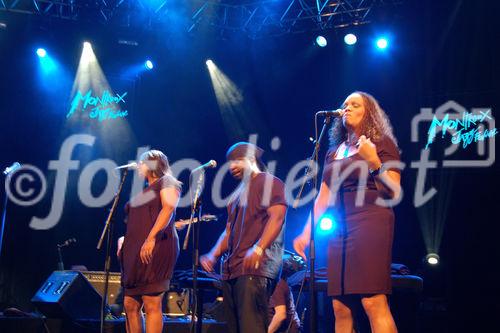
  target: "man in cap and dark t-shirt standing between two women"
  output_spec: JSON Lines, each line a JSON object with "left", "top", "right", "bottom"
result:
{"left": 200, "top": 142, "right": 287, "bottom": 333}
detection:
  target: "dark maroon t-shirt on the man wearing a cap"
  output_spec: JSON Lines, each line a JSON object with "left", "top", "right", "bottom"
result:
{"left": 222, "top": 172, "right": 287, "bottom": 280}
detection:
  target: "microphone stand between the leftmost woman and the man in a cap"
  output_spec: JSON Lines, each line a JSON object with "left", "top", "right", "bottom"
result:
{"left": 182, "top": 170, "right": 205, "bottom": 333}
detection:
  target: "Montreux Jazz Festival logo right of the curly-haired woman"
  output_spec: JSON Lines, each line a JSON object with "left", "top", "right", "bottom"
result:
{"left": 425, "top": 100, "right": 498, "bottom": 149}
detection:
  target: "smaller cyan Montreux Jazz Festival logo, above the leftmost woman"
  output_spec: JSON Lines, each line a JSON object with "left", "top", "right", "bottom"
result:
{"left": 66, "top": 89, "right": 128, "bottom": 121}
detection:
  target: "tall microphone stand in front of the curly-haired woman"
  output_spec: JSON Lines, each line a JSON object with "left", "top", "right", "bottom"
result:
{"left": 293, "top": 113, "right": 331, "bottom": 333}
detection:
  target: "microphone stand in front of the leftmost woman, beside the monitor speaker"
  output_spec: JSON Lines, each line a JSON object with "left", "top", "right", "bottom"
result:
{"left": 97, "top": 168, "right": 128, "bottom": 333}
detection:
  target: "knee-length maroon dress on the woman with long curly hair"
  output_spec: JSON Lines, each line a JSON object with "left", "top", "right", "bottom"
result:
{"left": 323, "top": 137, "right": 400, "bottom": 296}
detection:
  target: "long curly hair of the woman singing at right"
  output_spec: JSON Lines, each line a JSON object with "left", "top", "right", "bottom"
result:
{"left": 329, "top": 91, "right": 397, "bottom": 147}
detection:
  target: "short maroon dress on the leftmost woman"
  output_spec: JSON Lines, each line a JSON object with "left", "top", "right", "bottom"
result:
{"left": 121, "top": 175, "right": 180, "bottom": 296}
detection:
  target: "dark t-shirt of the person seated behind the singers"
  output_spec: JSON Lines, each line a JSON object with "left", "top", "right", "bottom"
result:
{"left": 268, "top": 279, "right": 300, "bottom": 332}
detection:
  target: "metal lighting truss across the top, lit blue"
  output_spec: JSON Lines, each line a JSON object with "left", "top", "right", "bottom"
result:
{"left": 0, "top": 0, "right": 404, "bottom": 38}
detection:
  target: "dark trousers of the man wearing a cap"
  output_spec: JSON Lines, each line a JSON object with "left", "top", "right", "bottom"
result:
{"left": 222, "top": 275, "right": 275, "bottom": 333}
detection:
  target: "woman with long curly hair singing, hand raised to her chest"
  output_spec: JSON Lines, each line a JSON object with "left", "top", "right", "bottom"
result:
{"left": 294, "top": 92, "right": 401, "bottom": 333}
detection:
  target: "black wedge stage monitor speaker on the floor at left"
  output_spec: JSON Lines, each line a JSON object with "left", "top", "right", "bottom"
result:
{"left": 31, "top": 271, "right": 102, "bottom": 320}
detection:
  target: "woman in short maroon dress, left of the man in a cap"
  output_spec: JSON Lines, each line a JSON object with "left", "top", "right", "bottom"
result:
{"left": 119, "top": 150, "right": 181, "bottom": 333}
